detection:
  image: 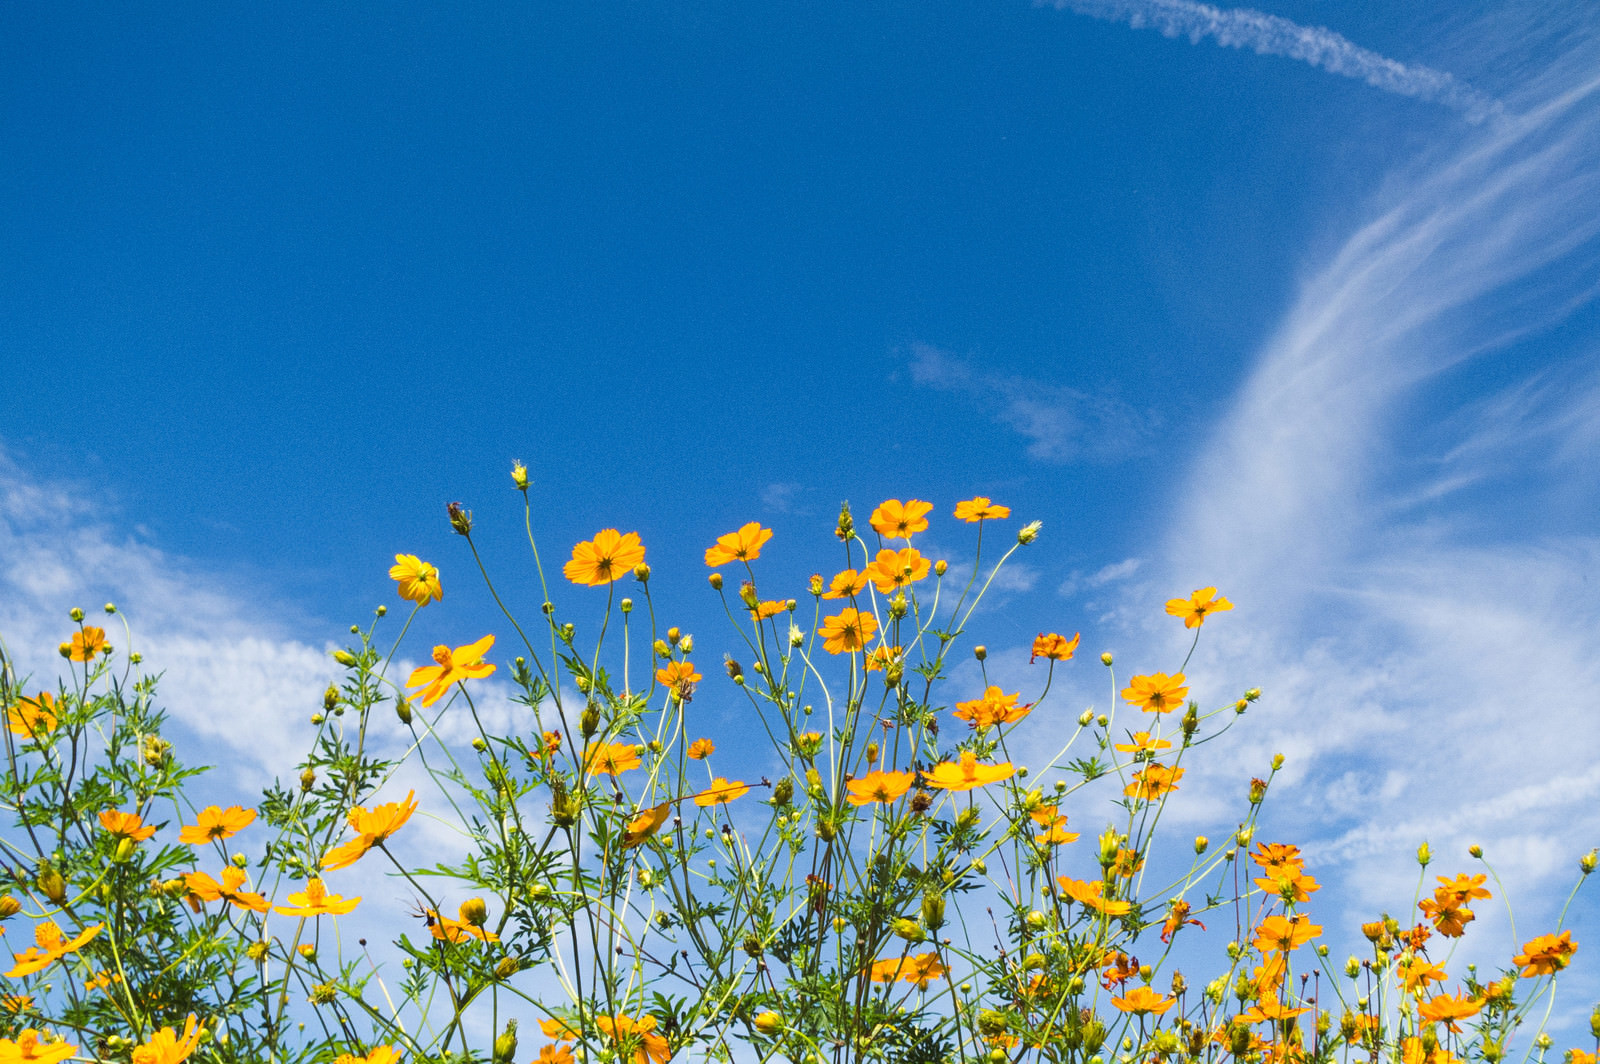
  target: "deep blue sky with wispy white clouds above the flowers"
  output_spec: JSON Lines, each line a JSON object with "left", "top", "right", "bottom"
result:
{"left": 0, "top": 0, "right": 1600, "bottom": 1043}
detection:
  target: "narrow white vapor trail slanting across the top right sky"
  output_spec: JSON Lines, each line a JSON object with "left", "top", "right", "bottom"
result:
{"left": 1053, "top": 0, "right": 1501, "bottom": 122}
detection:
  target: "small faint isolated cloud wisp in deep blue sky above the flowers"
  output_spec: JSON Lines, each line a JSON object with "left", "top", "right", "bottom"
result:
{"left": 910, "top": 344, "right": 1150, "bottom": 462}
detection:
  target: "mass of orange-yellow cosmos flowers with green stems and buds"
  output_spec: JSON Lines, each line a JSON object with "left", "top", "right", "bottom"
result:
{"left": 0, "top": 480, "right": 1600, "bottom": 1064}
